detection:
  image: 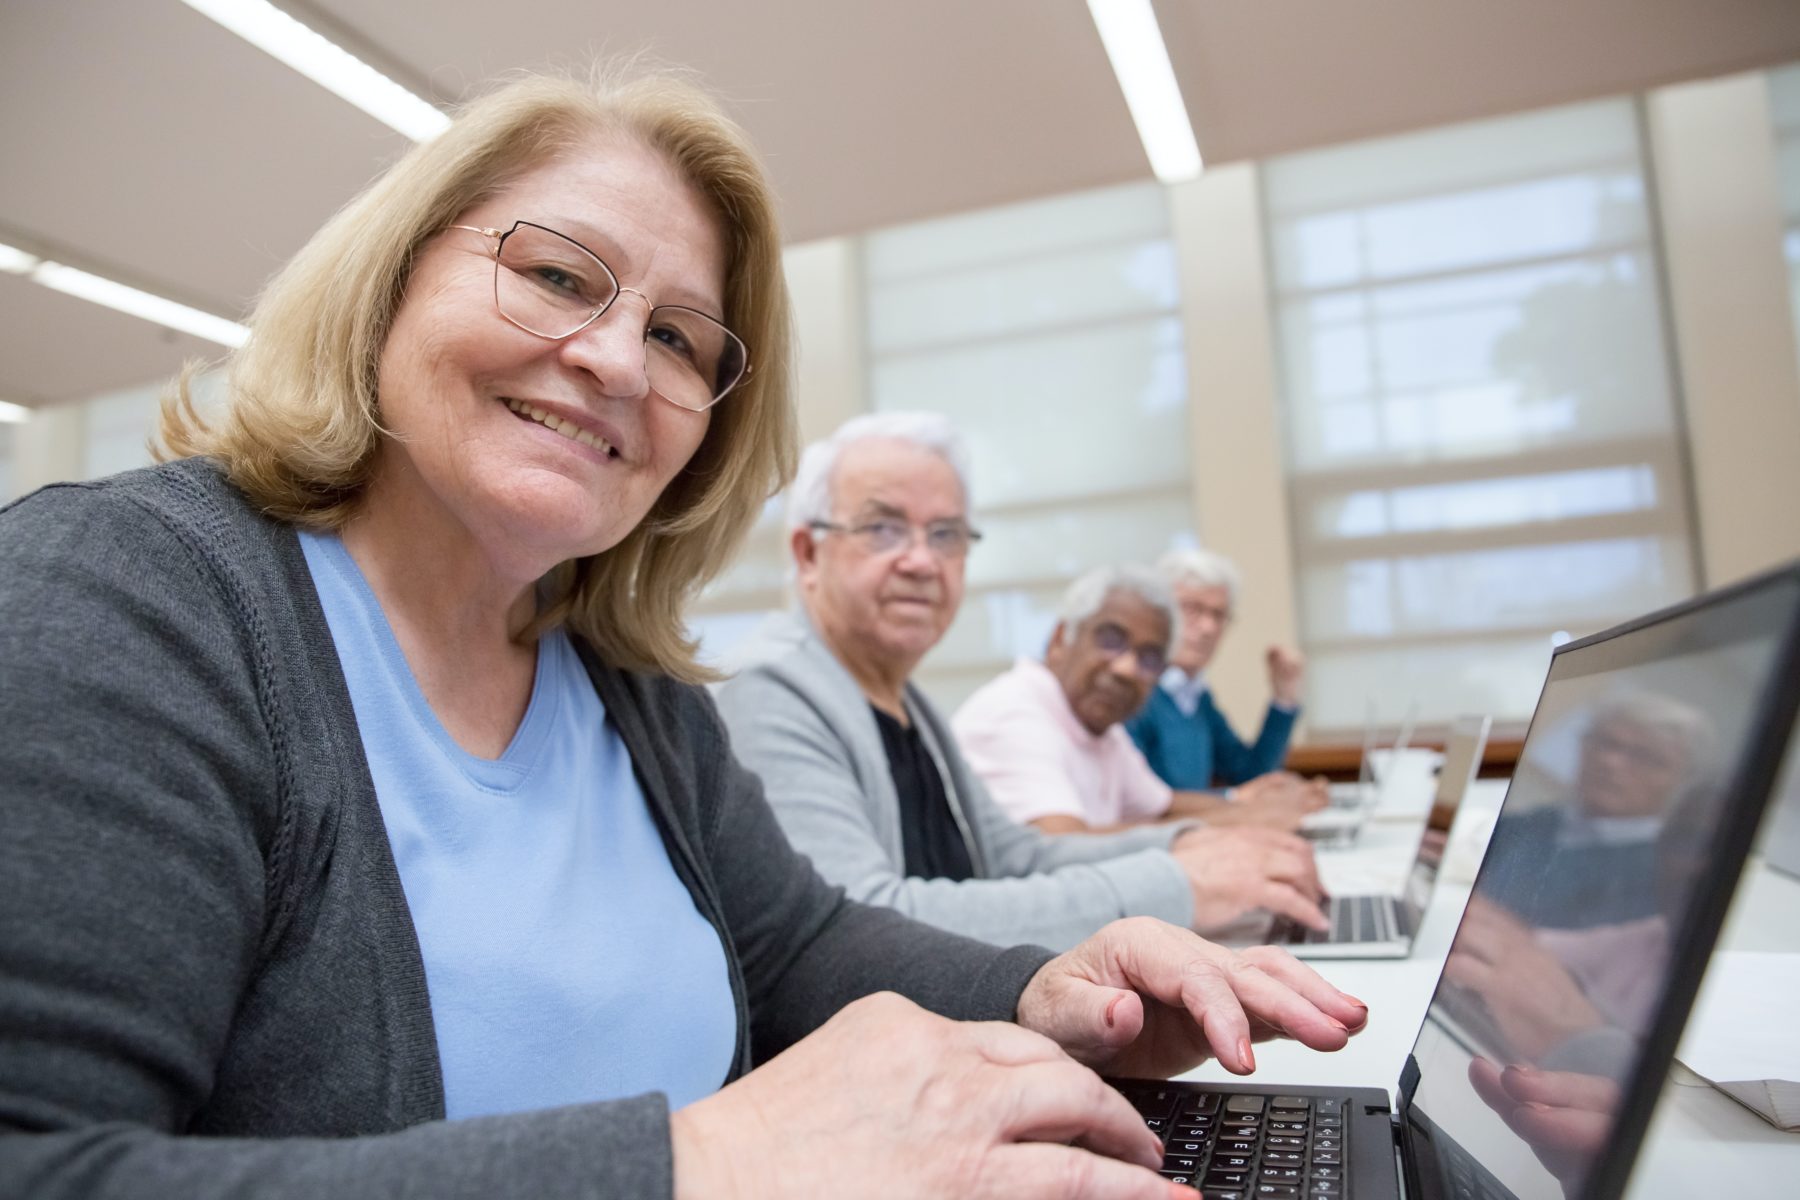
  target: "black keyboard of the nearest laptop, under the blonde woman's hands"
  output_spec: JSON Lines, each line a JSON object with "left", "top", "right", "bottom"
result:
{"left": 1112, "top": 1079, "right": 1350, "bottom": 1200}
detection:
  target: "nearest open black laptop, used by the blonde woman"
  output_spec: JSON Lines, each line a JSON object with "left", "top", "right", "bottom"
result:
{"left": 1116, "top": 563, "right": 1800, "bottom": 1200}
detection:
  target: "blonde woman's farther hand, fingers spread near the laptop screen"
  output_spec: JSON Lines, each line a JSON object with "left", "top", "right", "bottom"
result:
{"left": 1019, "top": 918, "right": 1368, "bottom": 1079}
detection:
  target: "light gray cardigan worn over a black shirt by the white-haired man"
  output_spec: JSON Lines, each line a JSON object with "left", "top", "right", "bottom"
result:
{"left": 718, "top": 613, "right": 1193, "bottom": 950}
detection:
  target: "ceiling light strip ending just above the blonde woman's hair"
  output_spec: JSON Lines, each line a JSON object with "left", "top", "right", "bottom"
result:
{"left": 182, "top": 0, "right": 450, "bottom": 142}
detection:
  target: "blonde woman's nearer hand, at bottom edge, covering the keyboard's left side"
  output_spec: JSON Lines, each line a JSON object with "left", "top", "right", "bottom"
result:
{"left": 670, "top": 993, "right": 1193, "bottom": 1200}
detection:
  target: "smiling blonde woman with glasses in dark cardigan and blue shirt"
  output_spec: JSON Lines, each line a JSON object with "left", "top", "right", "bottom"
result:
{"left": 0, "top": 63, "right": 1363, "bottom": 1200}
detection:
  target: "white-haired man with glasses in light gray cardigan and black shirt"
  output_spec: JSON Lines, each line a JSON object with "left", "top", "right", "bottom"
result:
{"left": 720, "top": 412, "right": 1321, "bottom": 948}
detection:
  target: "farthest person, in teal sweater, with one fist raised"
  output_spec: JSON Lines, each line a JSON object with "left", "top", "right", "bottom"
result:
{"left": 1125, "top": 551, "right": 1310, "bottom": 799}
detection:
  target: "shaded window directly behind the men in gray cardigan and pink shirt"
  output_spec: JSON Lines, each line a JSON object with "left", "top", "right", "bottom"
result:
{"left": 864, "top": 184, "right": 1193, "bottom": 711}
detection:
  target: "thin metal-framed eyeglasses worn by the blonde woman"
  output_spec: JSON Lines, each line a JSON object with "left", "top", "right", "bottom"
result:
{"left": 450, "top": 221, "right": 751, "bottom": 412}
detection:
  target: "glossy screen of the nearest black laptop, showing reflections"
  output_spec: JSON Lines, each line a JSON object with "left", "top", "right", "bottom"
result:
{"left": 1408, "top": 572, "right": 1800, "bottom": 1200}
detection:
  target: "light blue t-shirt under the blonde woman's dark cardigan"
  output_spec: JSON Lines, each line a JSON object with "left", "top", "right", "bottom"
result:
{"left": 301, "top": 533, "right": 738, "bottom": 1117}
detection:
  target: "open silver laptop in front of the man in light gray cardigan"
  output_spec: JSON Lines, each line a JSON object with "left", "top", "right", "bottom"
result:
{"left": 1267, "top": 716, "right": 1492, "bottom": 959}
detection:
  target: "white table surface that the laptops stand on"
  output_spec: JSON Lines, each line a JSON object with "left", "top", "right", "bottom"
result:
{"left": 1183, "top": 779, "right": 1800, "bottom": 1200}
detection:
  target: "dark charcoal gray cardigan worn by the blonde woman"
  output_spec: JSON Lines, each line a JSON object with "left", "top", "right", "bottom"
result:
{"left": 0, "top": 461, "right": 1049, "bottom": 1200}
